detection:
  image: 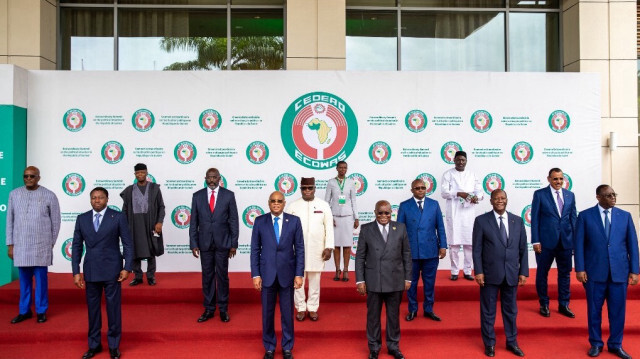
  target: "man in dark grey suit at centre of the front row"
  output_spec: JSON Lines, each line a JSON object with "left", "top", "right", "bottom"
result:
{"left": 356, "top": 201, "right": 411, "bottom": 359}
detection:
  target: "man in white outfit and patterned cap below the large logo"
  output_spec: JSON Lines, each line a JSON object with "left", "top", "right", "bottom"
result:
{"left": 285, "top": 177, "right": 334, "bottom": 321}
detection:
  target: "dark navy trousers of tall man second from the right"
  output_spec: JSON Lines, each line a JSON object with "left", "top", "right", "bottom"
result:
{"left": 536, "top": 243, "right": 572, "bottom": 306}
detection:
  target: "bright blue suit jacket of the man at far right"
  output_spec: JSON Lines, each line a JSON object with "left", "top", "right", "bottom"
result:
{"left": 574, "top": 205, "right": 638, "bottom": 283}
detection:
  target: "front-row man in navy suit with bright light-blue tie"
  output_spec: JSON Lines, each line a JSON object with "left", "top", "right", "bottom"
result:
{"left": 251, "top": 192, "right": 304, "bottom": 359}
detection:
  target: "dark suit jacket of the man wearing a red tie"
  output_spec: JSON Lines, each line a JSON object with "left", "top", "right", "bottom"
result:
{"left": 189, "top": 187, "right": 239, "bottom": 251}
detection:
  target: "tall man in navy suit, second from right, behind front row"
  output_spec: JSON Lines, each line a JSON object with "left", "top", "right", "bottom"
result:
{"left": 531, "top": 168, "right": 578, "bottom": 318}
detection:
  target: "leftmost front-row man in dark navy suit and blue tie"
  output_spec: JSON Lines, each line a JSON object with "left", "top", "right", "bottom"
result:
{"left": 71, "top": 187, "right": 133, "bottom": 359}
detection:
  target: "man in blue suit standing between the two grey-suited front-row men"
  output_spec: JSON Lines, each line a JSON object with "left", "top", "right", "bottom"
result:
{"left": 398, "top": 179, "right": 447, "bottom": 322}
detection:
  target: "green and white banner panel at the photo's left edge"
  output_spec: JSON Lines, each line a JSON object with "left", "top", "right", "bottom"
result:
{"left": 0, "top": 65, "right": 27, "bottom": 285}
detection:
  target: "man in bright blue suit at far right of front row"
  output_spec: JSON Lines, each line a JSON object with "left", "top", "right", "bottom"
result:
{"left": 574, "top": 185, "right": 639, "bottom": 359}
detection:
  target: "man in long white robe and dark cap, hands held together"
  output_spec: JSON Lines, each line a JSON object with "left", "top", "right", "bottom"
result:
{"left": 441, "top": 151, "right": 484, "bottom": 280}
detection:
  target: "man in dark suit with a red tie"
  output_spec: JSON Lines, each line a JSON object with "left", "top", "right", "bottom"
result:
{"left": 189, "top": 168, "right": 238, "bottom": 323}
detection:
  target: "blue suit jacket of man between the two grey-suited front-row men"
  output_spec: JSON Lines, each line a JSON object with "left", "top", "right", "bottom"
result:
{"left": 398, "top": 197, "right": 447, "bottom": 259}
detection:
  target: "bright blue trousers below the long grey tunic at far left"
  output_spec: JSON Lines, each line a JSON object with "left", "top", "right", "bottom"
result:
{"left": 18, "top": 267, "right": 49, "bottom": 314}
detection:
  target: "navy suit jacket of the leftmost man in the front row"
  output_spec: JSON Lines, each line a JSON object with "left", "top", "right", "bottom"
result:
{"left": 71, "top": 208, "right": 133, "bottom": 282}
